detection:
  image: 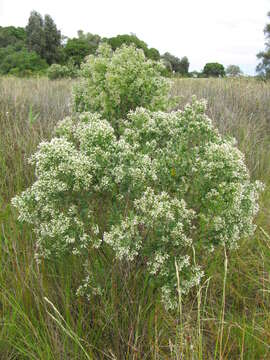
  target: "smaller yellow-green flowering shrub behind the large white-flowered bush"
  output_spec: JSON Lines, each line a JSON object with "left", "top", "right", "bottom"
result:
{"left": 73, "top": 43, "right": 170, "bottom": 131}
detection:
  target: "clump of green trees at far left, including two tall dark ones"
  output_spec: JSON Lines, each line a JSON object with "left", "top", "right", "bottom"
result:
{"left": 0, "top": 11, "right": 61, "bottom": 76}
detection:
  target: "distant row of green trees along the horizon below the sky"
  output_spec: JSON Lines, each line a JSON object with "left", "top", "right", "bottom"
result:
{"left": 0, "top": 11, "right": 263, "bottom": 77}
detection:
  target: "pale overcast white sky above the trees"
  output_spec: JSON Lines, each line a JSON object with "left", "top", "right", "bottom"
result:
{"left": 0, "top": 0, "right": 270, "bottom": 75}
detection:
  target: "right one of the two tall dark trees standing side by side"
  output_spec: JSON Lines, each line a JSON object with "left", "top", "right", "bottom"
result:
{"left": 43, "top": 15, "right": 61, "bottom": 65}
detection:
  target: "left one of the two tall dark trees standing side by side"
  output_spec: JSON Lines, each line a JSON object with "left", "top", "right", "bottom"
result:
{"left": 25, "top": 11, "right": 45, "bottom": 57}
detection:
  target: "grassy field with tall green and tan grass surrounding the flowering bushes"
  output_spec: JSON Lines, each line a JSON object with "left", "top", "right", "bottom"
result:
{"left": 0, "top": 78, "right": 270, "bottom": 360}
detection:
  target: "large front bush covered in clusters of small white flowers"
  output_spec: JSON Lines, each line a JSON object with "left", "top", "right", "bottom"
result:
{"left": 13, "top": 98, "right": 262, "bottom": 308}
